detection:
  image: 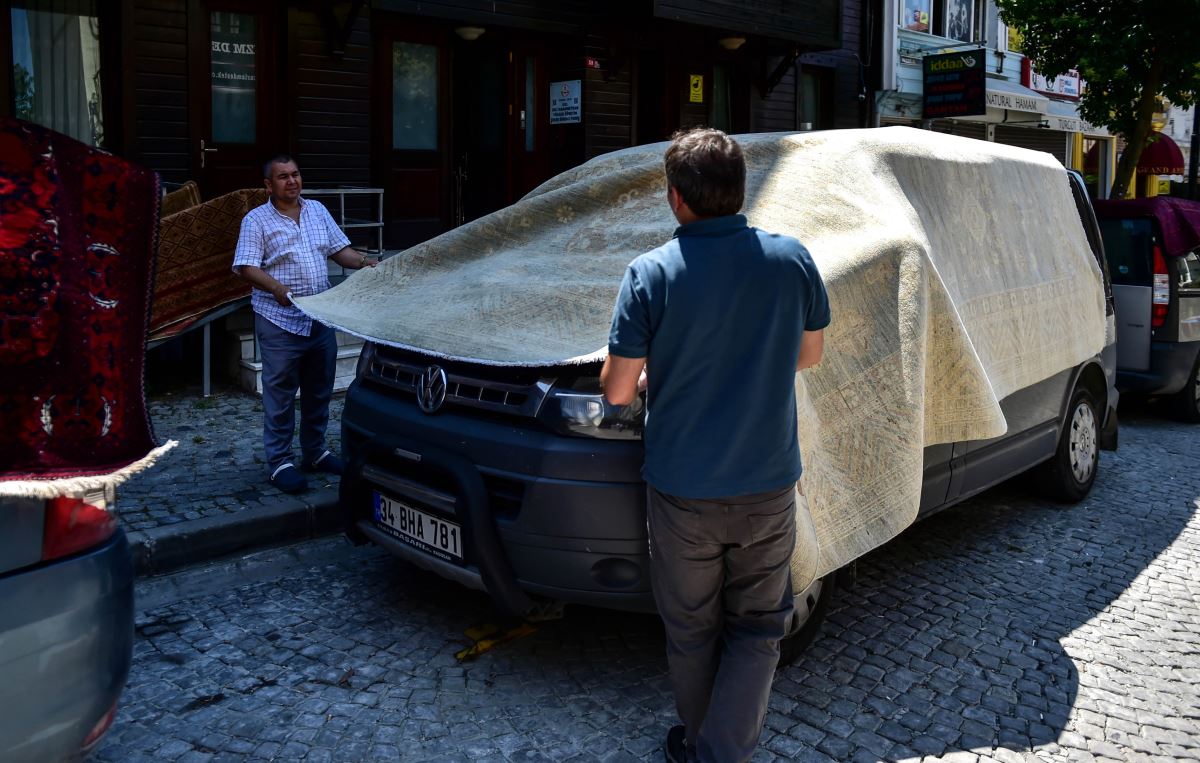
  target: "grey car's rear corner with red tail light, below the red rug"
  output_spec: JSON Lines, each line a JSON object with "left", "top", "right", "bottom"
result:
{"left": 0, "top": 487, "right": 133, "bottom": 763}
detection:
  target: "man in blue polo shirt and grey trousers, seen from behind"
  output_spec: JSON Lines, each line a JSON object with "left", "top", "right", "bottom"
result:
{"left": 600, "top": 130, "right": 829, "bottom": 763}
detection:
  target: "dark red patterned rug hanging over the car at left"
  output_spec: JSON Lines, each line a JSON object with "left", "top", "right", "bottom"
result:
{"left": 0, "top": 119, "right": 158, "bottom": 486}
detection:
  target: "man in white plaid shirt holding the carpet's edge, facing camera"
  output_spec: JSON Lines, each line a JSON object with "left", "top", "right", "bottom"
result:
{"left": 233, "top": 156, "right": 374, "bottom": 493}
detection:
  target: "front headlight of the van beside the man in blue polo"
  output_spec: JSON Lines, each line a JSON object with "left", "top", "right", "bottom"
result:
{"left": 538, "top": 378, "right": 646, "bottom": 440}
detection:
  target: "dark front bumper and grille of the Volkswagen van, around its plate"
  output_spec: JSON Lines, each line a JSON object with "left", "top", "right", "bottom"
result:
{"left": 340, "top": 382, "right": 654, "bottom": 614}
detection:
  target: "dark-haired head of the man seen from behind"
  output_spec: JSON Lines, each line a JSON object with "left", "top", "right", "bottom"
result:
{"left": 664, "top": 127, "right": 746, "bottom": 217}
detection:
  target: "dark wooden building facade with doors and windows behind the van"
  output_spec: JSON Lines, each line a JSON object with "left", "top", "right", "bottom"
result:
{"left": 0, "top": 0, "right": 870, "bottom": 247}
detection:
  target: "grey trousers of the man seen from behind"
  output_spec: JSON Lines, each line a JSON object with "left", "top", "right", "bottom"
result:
{"left": 647, "top": 485, "right": 796, "bottom": 763}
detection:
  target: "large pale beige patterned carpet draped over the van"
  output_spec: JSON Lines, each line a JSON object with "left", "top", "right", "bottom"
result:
{"left": 298, "top": 127, "right": 1105, "bottom": 587}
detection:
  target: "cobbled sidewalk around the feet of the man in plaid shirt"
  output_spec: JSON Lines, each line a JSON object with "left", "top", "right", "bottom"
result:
{"left": 119, "top": 386, "right": 343, "bottom": 530}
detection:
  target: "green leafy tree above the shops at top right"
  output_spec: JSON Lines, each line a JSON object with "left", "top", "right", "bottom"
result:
{"left": 996, "top": 0, "right": 1200, "bottom": 197}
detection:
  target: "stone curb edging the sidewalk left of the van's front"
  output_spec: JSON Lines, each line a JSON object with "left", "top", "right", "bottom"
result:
{"left": 126, "top": 485, "right": 341, "bottom": 577}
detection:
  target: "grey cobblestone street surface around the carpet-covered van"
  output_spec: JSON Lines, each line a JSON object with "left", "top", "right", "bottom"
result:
{"left": 97, "top": 408, "right": 1200, "bottom": 763}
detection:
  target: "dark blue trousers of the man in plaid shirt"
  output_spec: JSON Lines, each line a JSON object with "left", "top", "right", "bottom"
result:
{"left": 254, "top": 314, "right": 337, "bottom": 473}
